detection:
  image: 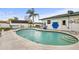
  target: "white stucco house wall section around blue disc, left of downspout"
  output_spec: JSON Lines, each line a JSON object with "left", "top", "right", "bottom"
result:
{"left": 43, "top": 17, "right": 68, "bottom": 30}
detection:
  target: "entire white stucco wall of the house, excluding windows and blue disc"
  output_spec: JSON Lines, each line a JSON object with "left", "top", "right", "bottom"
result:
{"left": 42, "top": 16, "right": 79, "bottom": 31}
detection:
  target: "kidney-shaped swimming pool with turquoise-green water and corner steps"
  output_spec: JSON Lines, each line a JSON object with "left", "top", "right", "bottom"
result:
{"left": 16, "top": 29, "right": 78, "bottom": 45}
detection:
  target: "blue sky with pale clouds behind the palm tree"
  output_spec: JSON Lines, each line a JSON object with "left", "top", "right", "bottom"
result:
{"left": 0, "top": 8, "right": 79, "bottom": 21}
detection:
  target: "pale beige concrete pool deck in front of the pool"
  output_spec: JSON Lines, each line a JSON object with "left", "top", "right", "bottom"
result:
{"left": 0, "top": 30, "right": 79, "bottom": 50}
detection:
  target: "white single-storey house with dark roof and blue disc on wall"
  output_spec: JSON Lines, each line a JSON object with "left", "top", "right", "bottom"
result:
{"left": 40, "top": 12, "right": 79, "bottom": 31}
